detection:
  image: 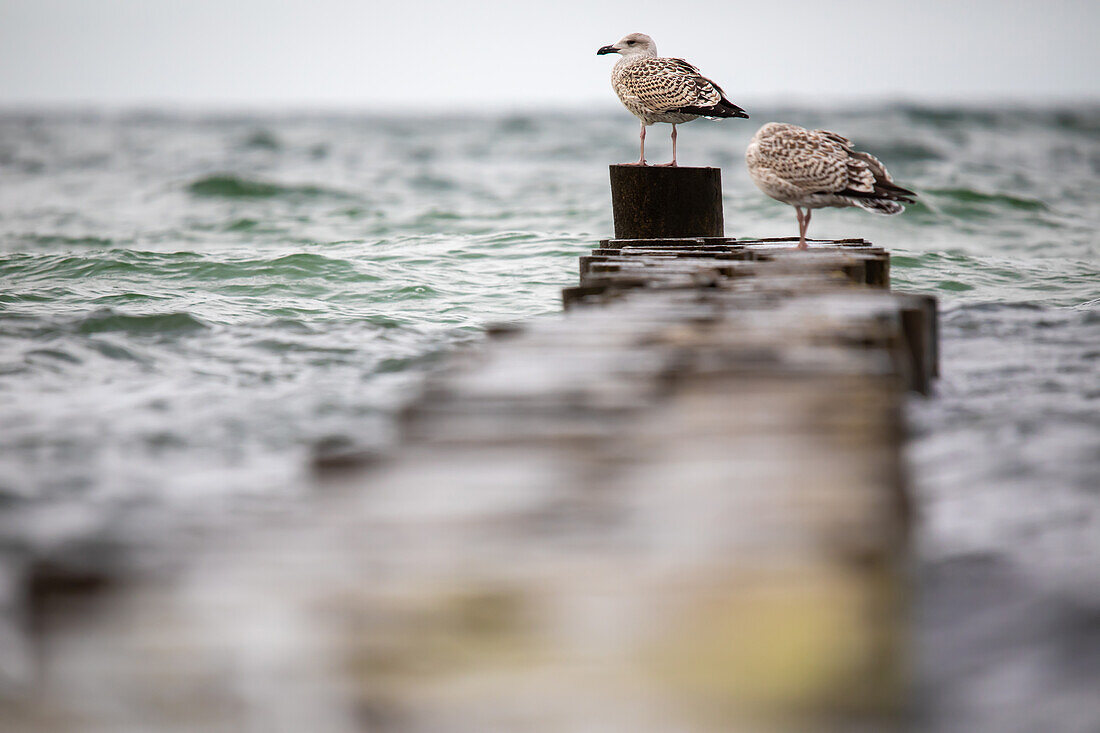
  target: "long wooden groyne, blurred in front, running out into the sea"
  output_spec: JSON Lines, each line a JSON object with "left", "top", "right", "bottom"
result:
{"left": 2, "top": 168, "right": 937, "bottom": 733}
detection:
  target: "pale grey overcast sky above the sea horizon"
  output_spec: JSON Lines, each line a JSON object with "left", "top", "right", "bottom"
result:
{"left": 0, "top": 0, "right": 1100, "bottom": 108}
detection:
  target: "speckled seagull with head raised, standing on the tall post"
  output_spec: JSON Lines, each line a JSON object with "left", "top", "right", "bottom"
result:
{"left": 596, "top": 33, "right": 748, "bottom": 166}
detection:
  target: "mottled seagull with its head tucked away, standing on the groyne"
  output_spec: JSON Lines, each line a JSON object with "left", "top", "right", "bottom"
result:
{"left": 745, "top": 122, "right": 916, "bottom": 250}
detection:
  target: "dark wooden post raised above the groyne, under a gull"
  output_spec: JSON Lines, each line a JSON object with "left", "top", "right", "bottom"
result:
{"left": 611, "top": 165, "right": 725, "bottom": 239}
